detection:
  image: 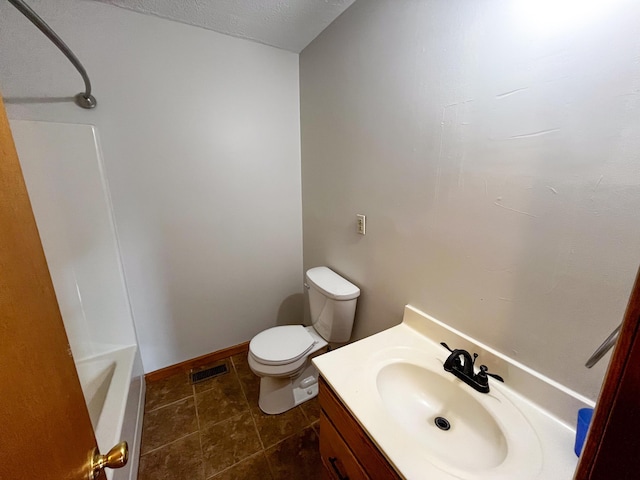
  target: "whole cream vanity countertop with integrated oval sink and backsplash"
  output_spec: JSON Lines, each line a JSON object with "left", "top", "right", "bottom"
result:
{"left": 314, "top": 306, "right": 584, "bottom": 480}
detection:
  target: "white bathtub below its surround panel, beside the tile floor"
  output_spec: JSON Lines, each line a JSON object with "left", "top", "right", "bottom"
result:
{"left": 76, "top": 346, "right": 144, "bottom": 480}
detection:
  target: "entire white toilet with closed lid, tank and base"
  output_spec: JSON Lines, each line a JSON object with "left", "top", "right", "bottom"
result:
{"left": 249, "top": 267, "right": 360, "bottom": 414}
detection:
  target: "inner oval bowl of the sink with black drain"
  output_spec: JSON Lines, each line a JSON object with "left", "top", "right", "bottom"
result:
{"left": 377, "top": 362, "right": 507, "bottom": 470}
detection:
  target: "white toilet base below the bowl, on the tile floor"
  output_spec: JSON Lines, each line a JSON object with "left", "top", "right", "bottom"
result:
{"left": 258, "top": 362, "right": 319, "bottom": 415}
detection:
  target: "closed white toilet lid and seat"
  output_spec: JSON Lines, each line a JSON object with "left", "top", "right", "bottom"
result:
{"left": 249, "top": 325, "right": 316, "bottom": 365}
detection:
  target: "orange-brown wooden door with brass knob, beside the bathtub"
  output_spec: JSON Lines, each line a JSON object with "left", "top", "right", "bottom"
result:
{"left": 0, "top": 97, "right": 106, "bottom": 480}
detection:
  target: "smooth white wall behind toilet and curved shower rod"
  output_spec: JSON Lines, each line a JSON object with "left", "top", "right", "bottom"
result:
{"left": 0, "top": 0, "right": 302, "bottom": 372}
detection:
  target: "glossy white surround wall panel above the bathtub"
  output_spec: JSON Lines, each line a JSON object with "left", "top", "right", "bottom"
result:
{"left": 11, "top": 120, "right": 137, "bottom": 361}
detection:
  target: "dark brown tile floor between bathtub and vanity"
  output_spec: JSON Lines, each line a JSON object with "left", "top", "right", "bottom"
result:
{"left": 138, "top": 354, "right": 321, "bottom": 480}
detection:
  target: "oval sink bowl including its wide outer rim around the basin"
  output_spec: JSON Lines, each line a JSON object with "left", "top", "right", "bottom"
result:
{"left": 369, "top": 347, "right": 541, "bottom": 480}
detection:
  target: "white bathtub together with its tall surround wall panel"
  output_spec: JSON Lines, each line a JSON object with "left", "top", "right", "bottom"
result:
{"left": 11, "top": 120, "right": 144, "bottom": 480}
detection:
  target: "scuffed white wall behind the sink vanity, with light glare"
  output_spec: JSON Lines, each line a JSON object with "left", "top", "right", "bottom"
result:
{"left": 300, "top": 0, "right": 640, "bottom": 398}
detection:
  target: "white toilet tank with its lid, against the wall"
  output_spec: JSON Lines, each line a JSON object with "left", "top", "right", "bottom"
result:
{"left": 306, "top": 267, "right": 360, "bottom": 343}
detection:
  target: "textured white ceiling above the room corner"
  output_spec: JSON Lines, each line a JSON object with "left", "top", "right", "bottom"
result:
{"left": 97, "top": 0, "right": 355, "bottom": 53}
